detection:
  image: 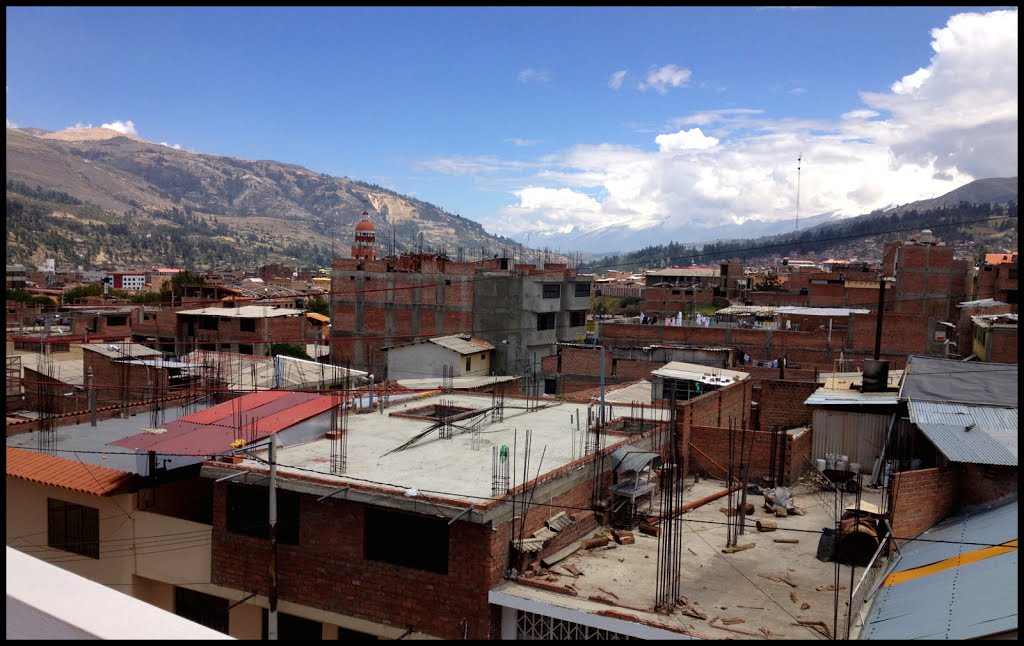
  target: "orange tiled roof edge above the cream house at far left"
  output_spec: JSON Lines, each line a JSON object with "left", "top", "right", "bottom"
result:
{"left": 6, "top": 446, "right": 134, "bottom": 496}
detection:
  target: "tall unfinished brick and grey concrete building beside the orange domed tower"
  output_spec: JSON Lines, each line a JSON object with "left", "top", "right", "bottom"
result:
{"left": 331, "top": 220, "right": 591, "bottom": 376}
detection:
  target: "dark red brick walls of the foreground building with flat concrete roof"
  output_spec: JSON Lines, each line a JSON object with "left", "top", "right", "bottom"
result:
{"left": 211, "top": 434, "right": 667, "bottom": 640}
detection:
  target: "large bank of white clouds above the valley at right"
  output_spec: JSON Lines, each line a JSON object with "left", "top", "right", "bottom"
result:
{"left": 432, "top": 9, "right": 1018, "bottom": 244}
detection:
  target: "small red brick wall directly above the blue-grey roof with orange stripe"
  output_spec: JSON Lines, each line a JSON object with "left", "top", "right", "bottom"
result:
{"left": 889, "top": 467, "right": 959, "bottom": 544}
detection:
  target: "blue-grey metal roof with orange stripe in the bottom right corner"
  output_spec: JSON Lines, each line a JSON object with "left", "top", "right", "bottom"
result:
{"left": 861, "top": 501, "right": 1018, "bottom": 640}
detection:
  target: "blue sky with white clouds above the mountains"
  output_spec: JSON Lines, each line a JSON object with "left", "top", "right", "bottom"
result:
{"left": 6, "top": 6, "right": 1018, "bottom": 252}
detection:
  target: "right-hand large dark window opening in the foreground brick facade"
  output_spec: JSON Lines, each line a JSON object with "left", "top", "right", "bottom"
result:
{"left": 364, "top": 507, "right": 449, "bottom": 574}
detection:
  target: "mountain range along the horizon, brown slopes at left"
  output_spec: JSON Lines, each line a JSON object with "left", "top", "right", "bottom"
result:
{"left": 6, "top": 127, "right": 1017, "bottom": 268}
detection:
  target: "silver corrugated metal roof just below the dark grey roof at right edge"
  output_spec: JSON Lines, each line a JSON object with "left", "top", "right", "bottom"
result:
{"left": 908, "top": 400, "right": 1017, "bottom": 467}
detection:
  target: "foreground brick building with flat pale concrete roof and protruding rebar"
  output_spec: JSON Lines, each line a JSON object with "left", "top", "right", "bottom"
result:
{"left": 203, "top": 394, "right": 670, "bottom": 639}
